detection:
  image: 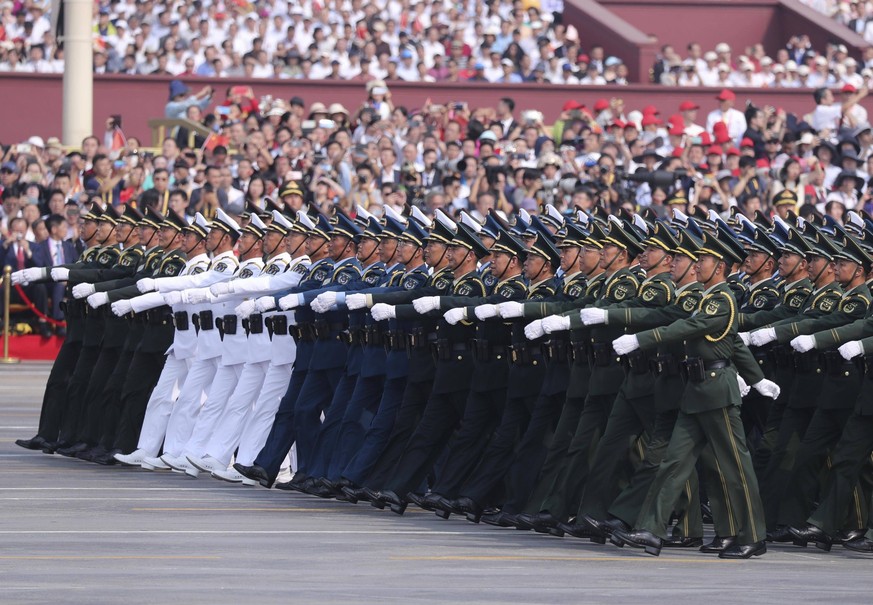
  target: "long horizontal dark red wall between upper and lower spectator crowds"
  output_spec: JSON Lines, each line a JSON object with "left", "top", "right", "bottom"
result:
{"left": 0, "top": 73, "right": 873, "bottom": 145}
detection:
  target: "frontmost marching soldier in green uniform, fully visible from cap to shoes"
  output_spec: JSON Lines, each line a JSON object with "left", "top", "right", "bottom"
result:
{"left": 613, "top": 233, "right": 779, "bottom": 558}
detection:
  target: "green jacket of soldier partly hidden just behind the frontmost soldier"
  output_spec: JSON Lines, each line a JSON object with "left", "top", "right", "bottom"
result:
{"left": 607, "top": 282, "right": 703, "bottom": 413}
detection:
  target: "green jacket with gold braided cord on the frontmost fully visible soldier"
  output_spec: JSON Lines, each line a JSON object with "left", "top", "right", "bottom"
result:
{"left": 637, "top": 282, "right": 764, "bottom": 414}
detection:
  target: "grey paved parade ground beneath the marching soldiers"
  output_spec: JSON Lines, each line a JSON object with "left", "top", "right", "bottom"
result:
{"left": 0, "top": 364, "right": 873, "bottom": 605}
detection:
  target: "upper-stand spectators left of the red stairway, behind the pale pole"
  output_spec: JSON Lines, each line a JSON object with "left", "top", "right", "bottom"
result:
{"left": 0, "top": 0, "right": 627, "bottom": 84}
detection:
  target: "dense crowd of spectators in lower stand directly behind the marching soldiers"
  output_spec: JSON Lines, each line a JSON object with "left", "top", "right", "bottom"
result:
{"left": 0, "top": 81, "right": 873, "bottom": 332}
